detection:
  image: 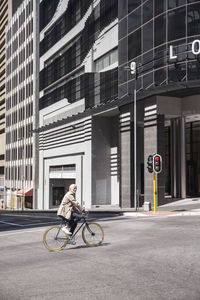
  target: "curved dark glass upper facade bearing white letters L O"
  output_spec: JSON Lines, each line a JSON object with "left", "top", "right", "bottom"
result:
{"left": 118, "top": 0, "right": 200, "bottom": 97}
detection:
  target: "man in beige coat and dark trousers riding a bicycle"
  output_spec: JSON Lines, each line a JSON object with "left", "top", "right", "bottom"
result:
{"left": 57, "top": 184, "right": 87, "bottom": 235}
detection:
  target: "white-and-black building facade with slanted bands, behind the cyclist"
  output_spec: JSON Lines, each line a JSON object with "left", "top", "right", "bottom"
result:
{"left": 38, "top": 0, "right": 119, "bottom": 209}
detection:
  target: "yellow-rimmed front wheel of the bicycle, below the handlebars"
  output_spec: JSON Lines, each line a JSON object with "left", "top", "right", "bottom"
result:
{"left": 82, "top": 222, "right": 104, "bottom": 247}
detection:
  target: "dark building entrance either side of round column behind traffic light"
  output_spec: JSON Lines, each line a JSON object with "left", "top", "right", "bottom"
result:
{"left": 164, "top": 121, "right": 200, "bottom": 198}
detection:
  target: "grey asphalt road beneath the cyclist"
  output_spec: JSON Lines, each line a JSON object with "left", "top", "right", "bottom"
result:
{"left": 0, "top": 216, "right": 200, "bottom": 300}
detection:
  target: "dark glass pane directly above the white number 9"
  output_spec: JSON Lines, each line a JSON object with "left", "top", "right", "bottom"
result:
{"left": 128, "top": 29, "right": 141, "bottom": 60}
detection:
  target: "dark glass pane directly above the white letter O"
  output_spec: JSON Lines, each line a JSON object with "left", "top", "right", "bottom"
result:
{"left": 187, "top": 3, "right": 200, "bottom": 36}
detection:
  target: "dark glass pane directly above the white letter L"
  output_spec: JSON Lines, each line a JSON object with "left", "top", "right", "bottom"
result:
{"left": 168, "top": 7, "right": 186, "bottom": 41}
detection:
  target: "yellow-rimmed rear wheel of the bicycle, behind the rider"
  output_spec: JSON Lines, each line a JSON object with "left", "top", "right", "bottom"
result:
{"left": 43, "top": 225, "right": 68, "bottom": 251}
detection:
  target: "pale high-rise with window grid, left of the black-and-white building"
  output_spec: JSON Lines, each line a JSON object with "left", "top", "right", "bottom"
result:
{"left": 5, "top": 0, "right": 39, "bottom": 208}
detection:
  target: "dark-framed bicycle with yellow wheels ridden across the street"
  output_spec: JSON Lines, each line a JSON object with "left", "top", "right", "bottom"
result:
{"left": 43, "top": 215, "right": 104, "bottom": 251}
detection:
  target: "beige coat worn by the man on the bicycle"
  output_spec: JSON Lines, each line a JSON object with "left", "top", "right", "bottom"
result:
{"left": 57, "top": 191, "right": 83, "bottom": 220}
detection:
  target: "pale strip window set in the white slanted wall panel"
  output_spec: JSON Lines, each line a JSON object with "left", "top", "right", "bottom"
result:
{"left": 94, "top": 48, "right": 118, "bottom": 72}
